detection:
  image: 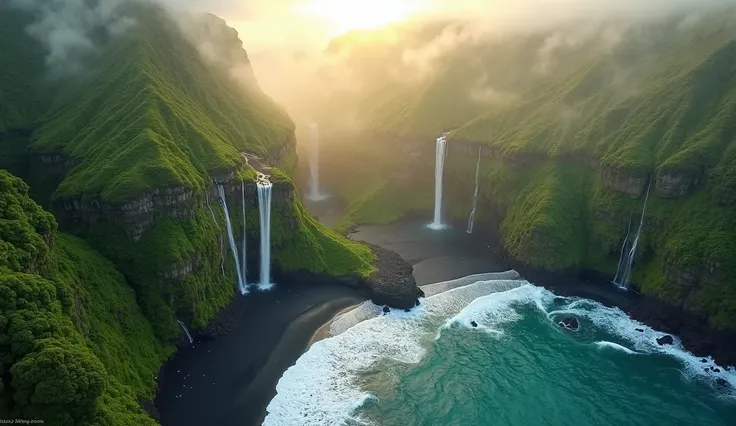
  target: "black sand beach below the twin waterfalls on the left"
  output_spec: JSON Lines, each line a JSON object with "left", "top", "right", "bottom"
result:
{"left": 156, "top": 284, "right": 364, "bottom": 426}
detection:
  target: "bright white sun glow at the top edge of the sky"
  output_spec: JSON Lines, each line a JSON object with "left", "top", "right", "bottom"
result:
{"left": 296, "top": 0, "right": 422, "bottom": 34}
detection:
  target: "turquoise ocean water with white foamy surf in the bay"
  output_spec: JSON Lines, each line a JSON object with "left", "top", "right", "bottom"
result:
{"left": 264, "top": 279, "right": 736, "bottom": 426}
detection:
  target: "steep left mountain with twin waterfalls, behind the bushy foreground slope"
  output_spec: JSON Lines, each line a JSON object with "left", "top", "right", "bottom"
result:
{"left": 0, "top": 2, "right": 373, "bottom": 342}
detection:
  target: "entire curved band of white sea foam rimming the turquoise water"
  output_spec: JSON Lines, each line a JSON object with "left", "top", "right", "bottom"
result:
{"left": 263, "top": 280, "right": 736, "bottom": 426}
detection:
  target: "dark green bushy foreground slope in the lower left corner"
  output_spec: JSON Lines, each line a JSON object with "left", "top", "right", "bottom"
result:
{"left": 0, "top": 171, "right": 167, "bottom": 425}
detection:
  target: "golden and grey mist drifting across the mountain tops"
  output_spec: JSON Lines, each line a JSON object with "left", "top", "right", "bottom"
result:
{"left": 9, "top": 0, "right": 736, "bottom": 122}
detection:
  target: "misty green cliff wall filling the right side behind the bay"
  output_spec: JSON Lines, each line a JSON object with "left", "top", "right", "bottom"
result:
{"left": 310, "top": 9, "right": 736, "bottom": 328}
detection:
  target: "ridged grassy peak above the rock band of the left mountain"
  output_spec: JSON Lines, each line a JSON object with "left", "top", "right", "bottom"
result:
{"left": 32, "top": 9, "right": 294, "bottom": 202}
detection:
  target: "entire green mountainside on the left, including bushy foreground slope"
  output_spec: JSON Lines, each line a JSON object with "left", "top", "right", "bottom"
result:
{"left": 0, "top": 2, "right": 375, "bottom": 425}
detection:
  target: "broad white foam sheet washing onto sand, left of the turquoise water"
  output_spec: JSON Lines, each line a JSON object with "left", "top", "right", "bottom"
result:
{"left": 263, "top": 274, "right": 527, "bottom": 426}
